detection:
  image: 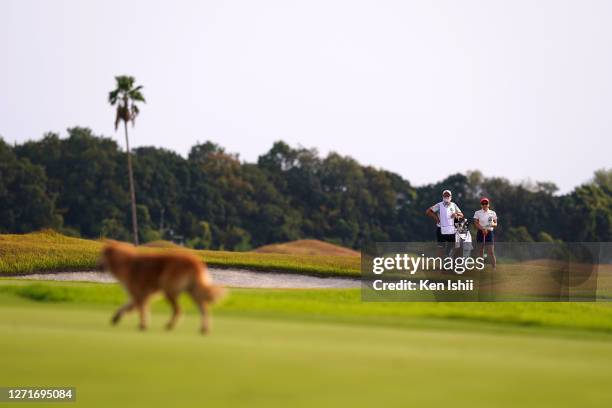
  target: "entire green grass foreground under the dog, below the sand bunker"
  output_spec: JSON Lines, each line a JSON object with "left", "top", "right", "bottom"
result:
{"left": 0, "top": 279, "right": 612, "bottom": 407}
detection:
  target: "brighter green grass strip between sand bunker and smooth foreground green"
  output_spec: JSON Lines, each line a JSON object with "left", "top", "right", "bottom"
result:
{"left": 0, "top": 279, "right": 612, "bottom": 336}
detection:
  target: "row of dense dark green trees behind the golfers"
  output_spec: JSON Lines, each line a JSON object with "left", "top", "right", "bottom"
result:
{"left": 0, "top": 128, "right": 612, "bottom": 250}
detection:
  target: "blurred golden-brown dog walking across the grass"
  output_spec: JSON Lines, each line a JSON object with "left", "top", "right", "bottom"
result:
{"left": 101, "top": 240, "right": 225, "bottom": 333}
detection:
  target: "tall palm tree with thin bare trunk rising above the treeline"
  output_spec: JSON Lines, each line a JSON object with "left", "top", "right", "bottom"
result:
{"left": 108, "top": 76, "right": 145, "bottom": 245}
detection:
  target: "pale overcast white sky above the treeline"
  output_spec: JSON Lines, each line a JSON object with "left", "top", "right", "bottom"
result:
{"left": 0, "top": 0, "right": 612, "bottom": 191}
